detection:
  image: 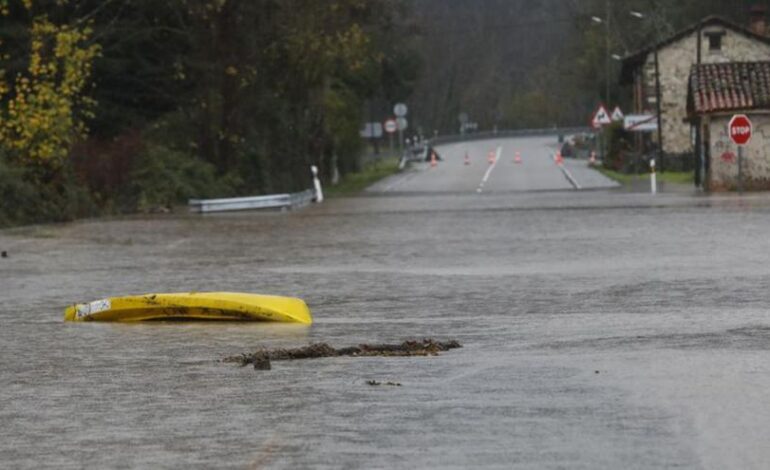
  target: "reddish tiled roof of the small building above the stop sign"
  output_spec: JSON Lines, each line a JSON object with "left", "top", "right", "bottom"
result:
{"left": 687, "top": 62, "right": 770, "bottom": 114}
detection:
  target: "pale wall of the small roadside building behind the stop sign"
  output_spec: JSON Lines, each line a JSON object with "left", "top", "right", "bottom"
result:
{"left": 706, "top": 113, "right": 770, "bottom": 191}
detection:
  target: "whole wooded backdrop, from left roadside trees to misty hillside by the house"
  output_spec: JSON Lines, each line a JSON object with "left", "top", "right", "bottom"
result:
{"left": 0, "top": 0, "right": 747, "bottom": 226}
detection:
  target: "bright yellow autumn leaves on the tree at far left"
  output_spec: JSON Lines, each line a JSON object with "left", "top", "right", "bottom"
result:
{"left": 0, "top": 0, "right": 100, "bottom": 166}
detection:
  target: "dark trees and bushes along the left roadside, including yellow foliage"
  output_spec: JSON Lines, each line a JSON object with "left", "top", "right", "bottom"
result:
{"left": 0, "top": 0, "right": 419, "bottom": 226}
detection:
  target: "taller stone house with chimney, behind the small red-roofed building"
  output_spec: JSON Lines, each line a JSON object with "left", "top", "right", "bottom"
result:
{"left": 620, "top": 11, "right": 770, "bottom": 169}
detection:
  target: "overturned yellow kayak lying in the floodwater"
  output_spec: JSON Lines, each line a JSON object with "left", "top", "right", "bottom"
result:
{"left": 64, "top": 292, "right": 313, "bottom": 325}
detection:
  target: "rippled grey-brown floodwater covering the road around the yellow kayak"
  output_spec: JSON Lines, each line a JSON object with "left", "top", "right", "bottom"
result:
{"left": 0, "top": 135, "right": 770, "bottom": 469}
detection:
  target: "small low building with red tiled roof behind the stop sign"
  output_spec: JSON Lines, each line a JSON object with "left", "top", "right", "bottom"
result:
{"left": 687, "top": 61, "right": 770, "bottom": 191}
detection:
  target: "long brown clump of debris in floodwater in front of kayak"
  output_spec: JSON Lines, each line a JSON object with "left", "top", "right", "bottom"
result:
{"left": 222, "top": 338, "right": 462, "bottom": 370}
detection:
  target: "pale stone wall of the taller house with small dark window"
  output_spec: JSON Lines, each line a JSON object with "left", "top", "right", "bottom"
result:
{"left": 644, "top": 26, "right": 770, "bottom": 154}
